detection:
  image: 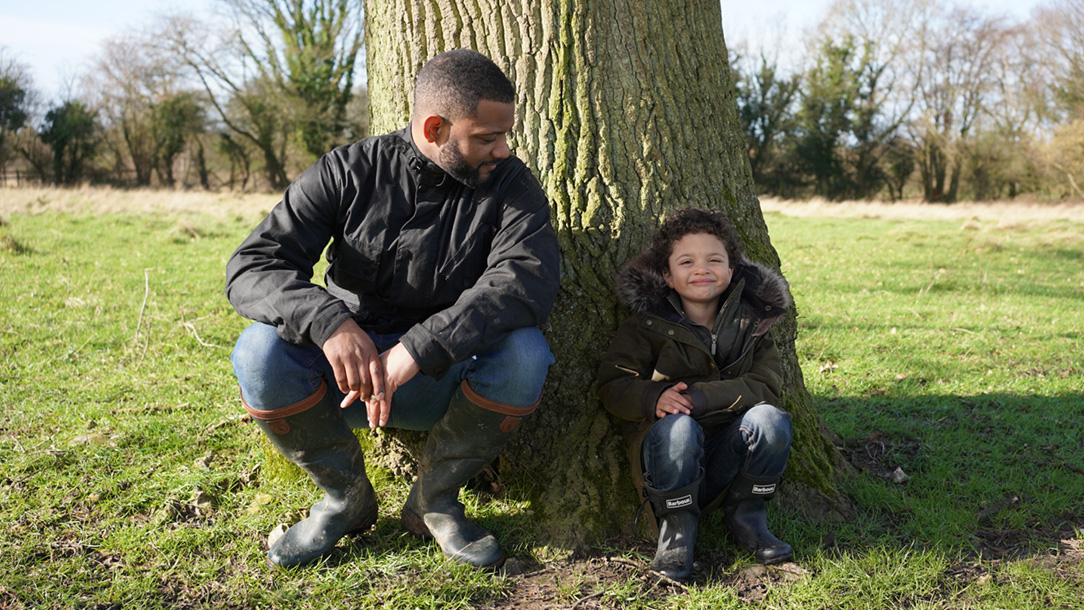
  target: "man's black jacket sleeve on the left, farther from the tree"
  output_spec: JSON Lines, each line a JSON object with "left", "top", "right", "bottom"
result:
{"left": 225, "top": 155, "right": 351, "bottom": 346}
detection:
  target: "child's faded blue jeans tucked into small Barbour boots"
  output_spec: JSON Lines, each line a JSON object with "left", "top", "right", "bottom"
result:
{"left": 641, "top": 404, "right": 792, "bottom": 507}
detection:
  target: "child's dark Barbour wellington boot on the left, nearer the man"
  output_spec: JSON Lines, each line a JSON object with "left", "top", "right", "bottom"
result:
{"left": 644, "top": 470, "right": 704, "bottom": 583}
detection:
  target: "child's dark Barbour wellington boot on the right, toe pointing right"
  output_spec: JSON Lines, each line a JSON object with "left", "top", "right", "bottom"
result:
{"left": 723, "top": 472, "right": 795, "bottom": 564}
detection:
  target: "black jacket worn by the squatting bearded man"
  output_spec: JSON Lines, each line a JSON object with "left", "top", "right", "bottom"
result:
{"left": 225, "top": 127, "right": 558, "bottom": 376}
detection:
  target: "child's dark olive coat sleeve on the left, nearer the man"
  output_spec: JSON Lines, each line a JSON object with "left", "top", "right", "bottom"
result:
{"left": 597, "top": 314, "right": 673, "bottom": 421}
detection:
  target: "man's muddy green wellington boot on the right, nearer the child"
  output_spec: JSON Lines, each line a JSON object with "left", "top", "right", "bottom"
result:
{"left": 402, "top": 381, "right": 538, "bottom": 569}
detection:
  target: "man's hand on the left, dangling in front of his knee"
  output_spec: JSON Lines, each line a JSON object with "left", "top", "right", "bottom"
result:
{"left": 323, "top": 319, "right": 385, "bottom": 418}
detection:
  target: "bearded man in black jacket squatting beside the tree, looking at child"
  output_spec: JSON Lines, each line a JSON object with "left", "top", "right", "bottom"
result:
{"left": 225, "top": 50, "right": 558, "bottom": 568}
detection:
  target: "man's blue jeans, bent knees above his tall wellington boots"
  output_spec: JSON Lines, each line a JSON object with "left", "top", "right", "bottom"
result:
{"left": 231, "top": 322, "right": 553, "bottom": 430}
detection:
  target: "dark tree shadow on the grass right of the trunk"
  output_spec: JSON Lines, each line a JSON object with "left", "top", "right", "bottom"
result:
{"left": 788, "top": 393, "right": 1084, "bottom": 559}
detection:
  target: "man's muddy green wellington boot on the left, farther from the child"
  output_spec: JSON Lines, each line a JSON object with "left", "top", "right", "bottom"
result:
{"left": 245, "top": 384, "right": 376, "bottom": 568}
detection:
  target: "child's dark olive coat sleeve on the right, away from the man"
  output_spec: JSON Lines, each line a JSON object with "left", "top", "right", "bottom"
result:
{"left": 688, "top": 333, "right": 783, "bottom": 425}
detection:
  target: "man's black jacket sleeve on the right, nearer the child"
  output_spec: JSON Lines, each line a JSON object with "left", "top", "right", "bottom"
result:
{"left": 400, "top": 168, "right": 559, "bottom": 376}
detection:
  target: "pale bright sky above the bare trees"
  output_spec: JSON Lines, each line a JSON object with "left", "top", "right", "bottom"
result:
{"left": 0, "top": 0, "right": 1041, "bottom": 101}
